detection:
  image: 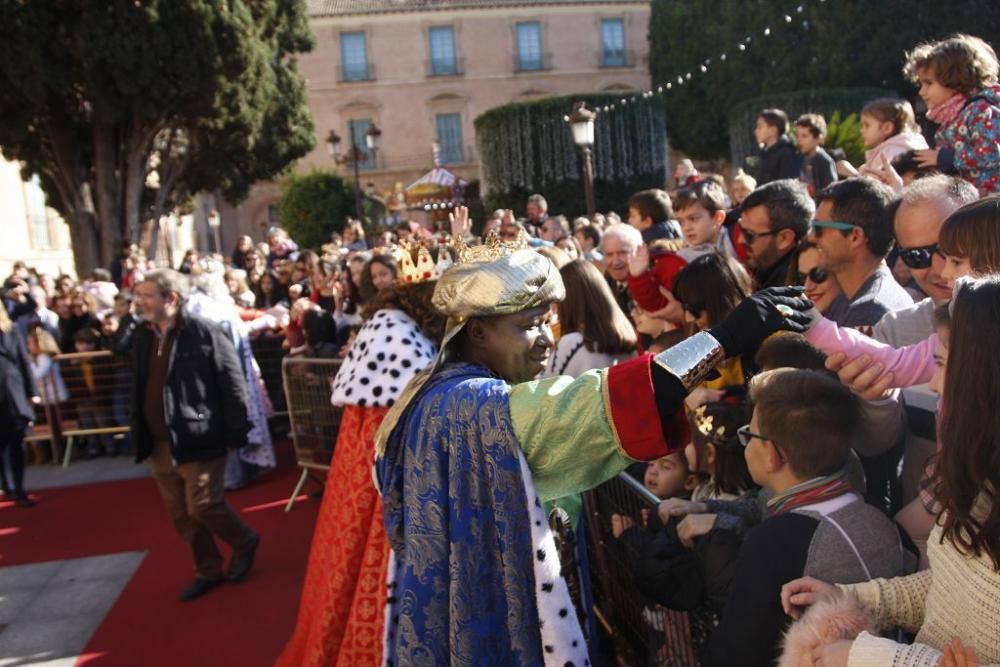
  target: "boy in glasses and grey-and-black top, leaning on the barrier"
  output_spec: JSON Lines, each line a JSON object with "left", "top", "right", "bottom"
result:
{"left": 684, "top": 368, "right": 905, "bottom": 666}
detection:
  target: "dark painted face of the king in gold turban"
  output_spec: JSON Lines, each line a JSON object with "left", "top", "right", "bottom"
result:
{"left": 466, "top": 304, "right": 554, "bottom": 384}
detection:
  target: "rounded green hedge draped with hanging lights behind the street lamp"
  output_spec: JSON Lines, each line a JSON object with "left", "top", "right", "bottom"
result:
{"left": 475, "top": 94, "right": 667, "bottom": 216}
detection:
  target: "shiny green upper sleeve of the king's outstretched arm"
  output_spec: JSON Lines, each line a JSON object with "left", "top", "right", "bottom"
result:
{"left": 510, "top": 370, "right": 635, "bottom": 500}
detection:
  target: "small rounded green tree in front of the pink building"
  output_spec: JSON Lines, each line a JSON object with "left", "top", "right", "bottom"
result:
{"left": 278, "top": 170, "right": 355, "bottom": 249}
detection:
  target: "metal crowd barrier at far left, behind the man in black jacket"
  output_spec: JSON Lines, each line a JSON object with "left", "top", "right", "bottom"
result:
{"left": 45, "top": 352, "right": 132, "bottom": 468}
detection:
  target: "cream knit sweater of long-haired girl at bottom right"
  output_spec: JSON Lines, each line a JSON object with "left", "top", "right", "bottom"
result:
{"left": 840, "top": 526, "right": 1000, "bottom": 667}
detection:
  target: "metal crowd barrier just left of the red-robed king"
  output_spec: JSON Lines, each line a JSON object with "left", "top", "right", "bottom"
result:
{"left": 281, "top": 357, "right": 341, "bottom": 512}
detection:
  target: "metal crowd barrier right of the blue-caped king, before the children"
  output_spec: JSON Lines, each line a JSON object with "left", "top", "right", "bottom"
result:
{"left": 583, "top": 473, "right": 697, "bottom": 667}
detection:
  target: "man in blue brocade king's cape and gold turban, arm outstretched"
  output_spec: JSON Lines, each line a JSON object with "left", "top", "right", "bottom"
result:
{"left": 375, "top": 232, "right": 811, "bottom": 667}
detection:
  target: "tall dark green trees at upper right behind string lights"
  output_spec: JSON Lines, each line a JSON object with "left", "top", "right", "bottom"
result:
{"left": 649, "top": 0, "right": 1000, "bottom": 158}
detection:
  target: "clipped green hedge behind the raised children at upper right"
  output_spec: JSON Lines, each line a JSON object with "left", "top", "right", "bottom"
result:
{"left": 729, "top": 88, "right": 898, "bottom": 173}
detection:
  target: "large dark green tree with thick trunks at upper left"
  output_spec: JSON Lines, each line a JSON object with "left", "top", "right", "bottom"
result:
{"left": 0, "top": 0, "right": 314, "bottom": 271}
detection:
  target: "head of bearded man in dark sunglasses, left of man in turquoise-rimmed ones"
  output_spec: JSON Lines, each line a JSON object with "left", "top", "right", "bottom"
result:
{"left": 740, "top": 179, "right": 816, "bottom": 288}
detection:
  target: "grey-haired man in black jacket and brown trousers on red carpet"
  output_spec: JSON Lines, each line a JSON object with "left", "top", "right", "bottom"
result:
{"left": 132, "top": 270, "right": 260, "bottom": 601}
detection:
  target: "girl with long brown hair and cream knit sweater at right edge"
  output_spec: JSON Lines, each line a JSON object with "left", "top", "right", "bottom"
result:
{"left": 781, "top": 273, "right": 1000, "bottom": 665}
